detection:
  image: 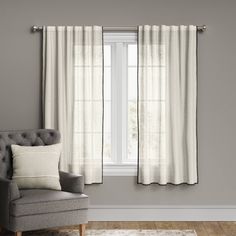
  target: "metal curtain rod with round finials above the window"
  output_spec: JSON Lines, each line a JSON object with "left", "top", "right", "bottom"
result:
{"left": 31, "top": 25, "right": 206, "bottom": 33}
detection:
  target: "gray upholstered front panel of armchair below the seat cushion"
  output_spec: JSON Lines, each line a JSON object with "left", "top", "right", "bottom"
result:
{"left": 9, "top": 210, "right": 88, "bottom": 232}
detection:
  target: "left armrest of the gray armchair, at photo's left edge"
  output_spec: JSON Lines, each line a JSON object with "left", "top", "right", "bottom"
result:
{"left": 0, "top": 177, "right": 20, "bottom": 226}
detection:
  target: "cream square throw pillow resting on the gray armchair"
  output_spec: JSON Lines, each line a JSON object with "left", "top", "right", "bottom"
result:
{"left": 11, "top": 143, "right": 62, "bottom": 190}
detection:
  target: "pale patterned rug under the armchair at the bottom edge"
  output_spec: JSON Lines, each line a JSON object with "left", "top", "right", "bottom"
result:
{"left": 16, "top": 229, "right": 197, "bottom": 236}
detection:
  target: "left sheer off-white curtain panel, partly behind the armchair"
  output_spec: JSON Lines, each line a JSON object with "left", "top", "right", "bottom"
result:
{"left": 43, "top": 26, "right": 103, "bottom": 184}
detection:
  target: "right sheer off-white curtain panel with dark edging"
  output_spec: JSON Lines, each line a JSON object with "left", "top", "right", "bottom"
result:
{"left": 138, "top": 25, "right": 198, "bottom": 185}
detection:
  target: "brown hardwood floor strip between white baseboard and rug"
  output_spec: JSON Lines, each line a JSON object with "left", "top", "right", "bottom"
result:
{"left": 87, "top": 221, "right": 236, "bottom": 236}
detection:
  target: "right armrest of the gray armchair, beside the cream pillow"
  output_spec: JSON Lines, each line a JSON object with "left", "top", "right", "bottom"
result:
{"left": 59, "top": 171, "right": 84, "bottom": 193}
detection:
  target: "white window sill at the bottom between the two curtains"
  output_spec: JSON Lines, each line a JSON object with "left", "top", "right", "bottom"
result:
{"left": 103, "top": 163, "right": 137, "bottom": 176}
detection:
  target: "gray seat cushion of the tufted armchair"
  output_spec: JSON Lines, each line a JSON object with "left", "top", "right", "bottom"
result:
{"left": 10, "top": 189, "right": 88, "bottom": 217}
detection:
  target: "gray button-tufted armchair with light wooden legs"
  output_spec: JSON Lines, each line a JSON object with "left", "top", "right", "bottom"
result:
{"left": 0, "top": 129, "right": 88, "bottom": 236}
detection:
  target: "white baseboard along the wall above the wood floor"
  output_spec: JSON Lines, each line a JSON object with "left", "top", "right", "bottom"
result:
{"left": 89, "top": 205, "right": 236, "bottom": 221}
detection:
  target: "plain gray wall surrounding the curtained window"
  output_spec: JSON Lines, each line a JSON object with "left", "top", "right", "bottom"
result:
{"left": 0, "top": 0, "right": 236, "bottom": 205}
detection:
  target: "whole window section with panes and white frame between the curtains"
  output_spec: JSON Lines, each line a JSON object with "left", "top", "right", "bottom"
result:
{"left": 103, "top": 32, "right": 138, "bottom": 175}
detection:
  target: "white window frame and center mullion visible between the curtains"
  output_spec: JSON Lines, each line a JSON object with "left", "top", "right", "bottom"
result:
{"left": 103, "top": 32, "right": 137, "bottom": 176}
